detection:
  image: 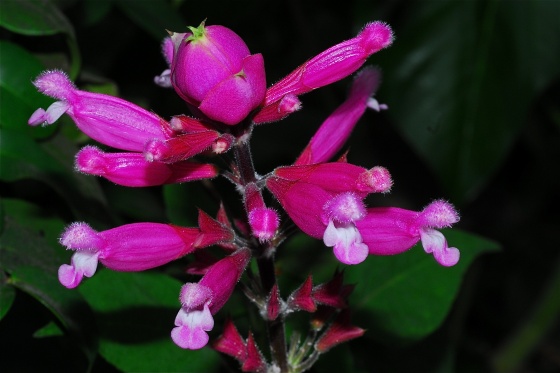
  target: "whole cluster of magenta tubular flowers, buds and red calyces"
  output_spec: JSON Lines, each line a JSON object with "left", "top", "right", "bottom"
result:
{"left": 28, "top": 22, "right": 459, "bottom": 371}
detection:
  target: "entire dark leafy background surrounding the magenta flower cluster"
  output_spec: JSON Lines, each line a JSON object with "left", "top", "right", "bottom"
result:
{"left": 0, "top": 0, "right": 560, "bottom": 373}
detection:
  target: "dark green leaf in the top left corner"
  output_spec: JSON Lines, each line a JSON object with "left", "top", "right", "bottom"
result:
{"left": 0, "top": 0, "right": 74, "bottom": 37}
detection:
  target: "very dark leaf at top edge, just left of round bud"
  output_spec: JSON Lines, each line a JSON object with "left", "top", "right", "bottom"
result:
{"left": 116, "top": 0, "right": 188, "bottom": 40}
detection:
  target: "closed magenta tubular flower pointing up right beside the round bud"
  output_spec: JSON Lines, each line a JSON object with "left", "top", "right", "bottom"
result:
{"left": 264, "top": 22, "right": 393, "bottom": 107}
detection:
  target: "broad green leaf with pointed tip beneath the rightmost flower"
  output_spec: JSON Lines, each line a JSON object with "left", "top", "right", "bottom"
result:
{"left": 345, "top": 229, "right": 499, "bottom": 341}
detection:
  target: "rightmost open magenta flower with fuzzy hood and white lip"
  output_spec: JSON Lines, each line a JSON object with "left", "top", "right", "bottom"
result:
{"left": 356, "top": 200, "right": 460, "bottom": 267}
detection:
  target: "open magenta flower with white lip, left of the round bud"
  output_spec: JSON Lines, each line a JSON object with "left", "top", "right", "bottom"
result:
{"left": 28, "top": 70, "right": 169, "bottom": 151}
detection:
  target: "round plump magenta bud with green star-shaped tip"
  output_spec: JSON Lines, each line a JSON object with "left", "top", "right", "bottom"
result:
{"left": 171, "top": 22, "right": 266, "bottom": 125}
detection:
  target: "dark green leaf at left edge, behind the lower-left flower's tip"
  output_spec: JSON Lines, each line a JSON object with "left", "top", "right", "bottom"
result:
{"left": 0, "top": 199, "right": 96, "bottom": 361}
